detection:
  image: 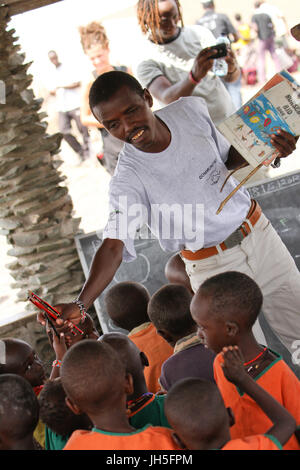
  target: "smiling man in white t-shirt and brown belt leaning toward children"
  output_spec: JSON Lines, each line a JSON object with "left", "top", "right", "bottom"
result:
{"left": 39, "top": 72, "right": 300, "bottom": 356}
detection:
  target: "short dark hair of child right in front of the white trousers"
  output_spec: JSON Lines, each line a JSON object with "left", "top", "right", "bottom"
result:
{"left": 198, "top": 271, "right": 263, "bottom": 328}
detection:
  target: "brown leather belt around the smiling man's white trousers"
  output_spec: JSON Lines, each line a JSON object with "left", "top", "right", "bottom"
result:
{"left": 180, "top": 200, "right": 262, "bottom": 261}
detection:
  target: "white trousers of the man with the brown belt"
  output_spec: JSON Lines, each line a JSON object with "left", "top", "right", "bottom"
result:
{"left": 183, "top": 214, "right": 300, "bottom": 353}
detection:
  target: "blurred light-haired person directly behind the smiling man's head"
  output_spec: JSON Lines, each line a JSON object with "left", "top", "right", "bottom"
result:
{"left": 79, "top": 21, "right": 129, "bottom": 176}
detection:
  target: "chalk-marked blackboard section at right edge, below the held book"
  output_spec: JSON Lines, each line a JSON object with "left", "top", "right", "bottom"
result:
{"left": 247, "top": 172, "right": 300, "bottom": 270}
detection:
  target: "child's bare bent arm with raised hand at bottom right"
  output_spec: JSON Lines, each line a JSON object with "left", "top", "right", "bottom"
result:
{"left": 222, "top": 346, "right": 296, "bottom": 445}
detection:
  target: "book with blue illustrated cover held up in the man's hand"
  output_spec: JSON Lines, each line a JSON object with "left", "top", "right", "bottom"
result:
{"left": 218, "top": 71, "right": 300, "bottom": 168}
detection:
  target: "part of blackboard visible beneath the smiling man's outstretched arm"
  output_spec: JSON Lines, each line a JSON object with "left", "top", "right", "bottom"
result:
{"left": 75, "top": 227, "right": 172, "bottom": 333}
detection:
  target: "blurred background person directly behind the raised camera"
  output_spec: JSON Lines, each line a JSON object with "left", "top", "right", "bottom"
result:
{"left": 196, "top": 0, "right": 242, "bottom": 109}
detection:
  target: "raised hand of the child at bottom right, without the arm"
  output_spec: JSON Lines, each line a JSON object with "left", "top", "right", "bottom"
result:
{"left": 222, "top": 346, "right": 247, "bottom": 385}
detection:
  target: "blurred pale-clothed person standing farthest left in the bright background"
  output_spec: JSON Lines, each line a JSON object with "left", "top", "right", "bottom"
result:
{"left": 48, "top": 51, "right": 89, "bottom": 161}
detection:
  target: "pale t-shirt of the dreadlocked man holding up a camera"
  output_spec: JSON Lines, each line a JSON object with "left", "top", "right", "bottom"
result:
{"left": 136, "top": 25, "right": 235, "bottom": 125}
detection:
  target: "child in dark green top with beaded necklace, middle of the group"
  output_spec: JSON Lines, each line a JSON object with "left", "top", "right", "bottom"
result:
{"left": 99, "top": 333, "right": 170, "bottom": 429}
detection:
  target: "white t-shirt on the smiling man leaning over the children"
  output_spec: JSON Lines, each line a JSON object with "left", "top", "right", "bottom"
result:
{"left": 103, "top": 97, "right": 250, "bottom": 261}
